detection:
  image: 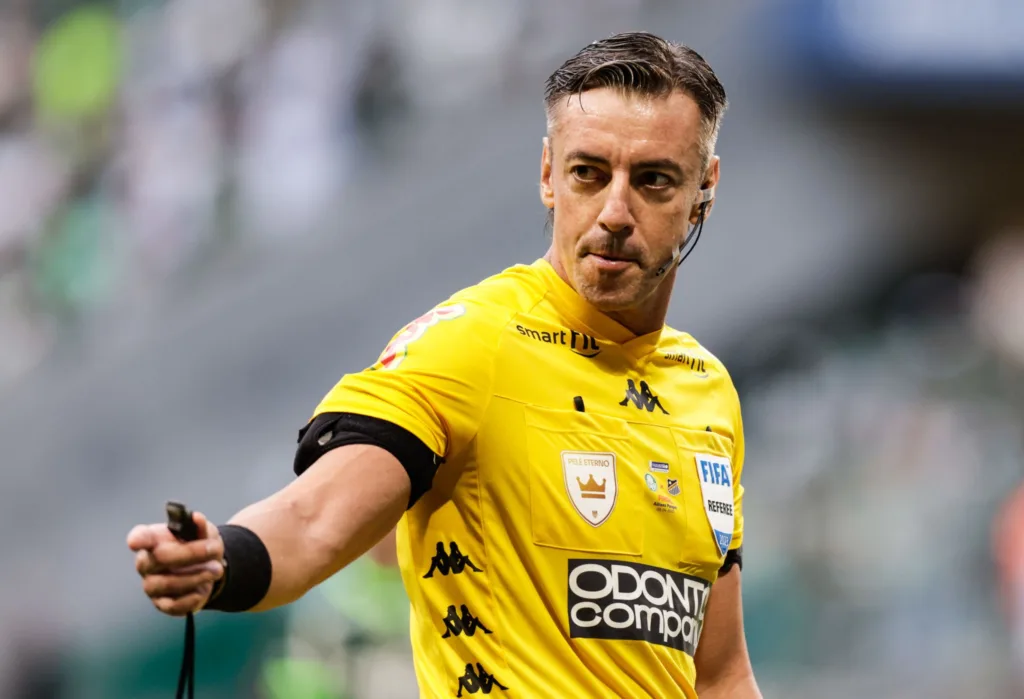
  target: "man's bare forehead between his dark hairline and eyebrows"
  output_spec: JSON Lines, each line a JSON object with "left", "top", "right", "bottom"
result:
{"left": 551, "top": 88, "right": 701, "bottom": 164}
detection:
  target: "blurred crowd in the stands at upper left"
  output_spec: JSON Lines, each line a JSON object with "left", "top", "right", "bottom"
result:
{"left": 0, "top": 0, "right": 642, "bottom": 390}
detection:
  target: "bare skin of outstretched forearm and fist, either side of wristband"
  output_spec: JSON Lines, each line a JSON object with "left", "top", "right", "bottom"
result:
{"left": 128, "top": 444, "right": 410, "bottom": 616}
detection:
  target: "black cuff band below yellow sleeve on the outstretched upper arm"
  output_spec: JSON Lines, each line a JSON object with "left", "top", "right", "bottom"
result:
{"left": 295, "top": 412, "right": 444, "bottom": 508}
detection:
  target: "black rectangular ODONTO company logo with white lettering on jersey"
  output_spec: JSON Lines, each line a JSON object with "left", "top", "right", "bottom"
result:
{"left": 568, "top": 559, "right": 711, "bottom": 656}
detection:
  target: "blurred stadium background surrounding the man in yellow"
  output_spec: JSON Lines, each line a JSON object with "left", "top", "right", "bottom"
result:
{"left": 0, "top": 0, "right": 1024, "bottom": 699}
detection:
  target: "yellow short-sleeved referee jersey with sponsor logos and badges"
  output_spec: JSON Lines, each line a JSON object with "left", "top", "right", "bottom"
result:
{"left": 316, "top": 260, "right": 743, "bottom": 699}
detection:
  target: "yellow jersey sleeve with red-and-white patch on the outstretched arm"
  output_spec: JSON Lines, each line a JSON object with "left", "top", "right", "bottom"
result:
{"left": 313, "top": 297, "right": 502, "bottom": 458}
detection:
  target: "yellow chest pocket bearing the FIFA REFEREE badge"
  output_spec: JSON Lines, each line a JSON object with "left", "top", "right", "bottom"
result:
{"left": 672, "top": 428, "right": 737, "bottom": 570}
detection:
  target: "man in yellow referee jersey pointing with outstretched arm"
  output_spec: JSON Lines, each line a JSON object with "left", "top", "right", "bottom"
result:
{"left": 128, "top": 34, "right": 760, "bottom": 699}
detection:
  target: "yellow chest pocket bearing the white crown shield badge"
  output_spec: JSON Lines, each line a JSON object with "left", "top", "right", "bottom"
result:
{"left": 525, "top": 405, "right": 643, "bottom": 556}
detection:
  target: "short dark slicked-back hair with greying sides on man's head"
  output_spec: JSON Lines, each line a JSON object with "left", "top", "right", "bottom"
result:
{"left": 544, "top": 32, "right": 728, "bottom": 167}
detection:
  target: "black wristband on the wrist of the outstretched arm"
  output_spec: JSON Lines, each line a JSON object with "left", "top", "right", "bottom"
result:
{"left": 204, "top": 524, "right": 271, "bottom": 612}
